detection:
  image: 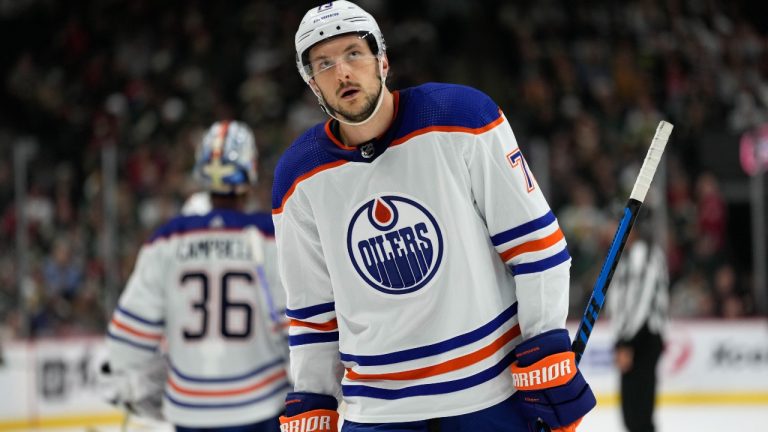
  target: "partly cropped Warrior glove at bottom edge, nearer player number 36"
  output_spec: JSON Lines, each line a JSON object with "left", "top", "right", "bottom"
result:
{"left": 280, "top": 392, "right": 339, "bottom": 432}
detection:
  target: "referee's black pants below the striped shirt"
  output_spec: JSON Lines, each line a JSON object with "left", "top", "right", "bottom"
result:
{"left": 621, "top": 326, "right": 663, "bottom": 432}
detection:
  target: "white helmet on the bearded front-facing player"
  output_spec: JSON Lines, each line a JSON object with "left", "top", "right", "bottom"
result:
{"left": 295, "top": 0, "right": 387, "bottom": 84}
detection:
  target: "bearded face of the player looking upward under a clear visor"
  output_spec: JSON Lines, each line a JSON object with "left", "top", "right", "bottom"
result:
{"left": 309, "top": 35, "right": 386, "bottom": 122}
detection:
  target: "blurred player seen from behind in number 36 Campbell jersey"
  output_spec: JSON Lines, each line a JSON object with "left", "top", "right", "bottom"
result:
{"left": 107, "top": 121, "right": 289, "bottom": 432}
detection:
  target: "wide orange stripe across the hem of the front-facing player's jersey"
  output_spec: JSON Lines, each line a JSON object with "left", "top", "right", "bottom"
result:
{"left": 346, "top": 324, "right": 520, "bottom": 381}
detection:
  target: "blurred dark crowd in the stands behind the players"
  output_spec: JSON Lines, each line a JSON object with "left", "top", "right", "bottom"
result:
{"left": 0, "top": 0, "right": 768, "bottom": 337}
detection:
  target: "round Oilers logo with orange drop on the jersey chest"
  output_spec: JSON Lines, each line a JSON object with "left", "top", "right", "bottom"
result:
{"left": 347, "top": 195, "right": 443, "bottom": 294}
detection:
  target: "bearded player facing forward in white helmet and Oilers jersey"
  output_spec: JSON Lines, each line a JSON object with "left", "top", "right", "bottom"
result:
{"left": 272, "top": 1, "right": 595, "bottom": 432}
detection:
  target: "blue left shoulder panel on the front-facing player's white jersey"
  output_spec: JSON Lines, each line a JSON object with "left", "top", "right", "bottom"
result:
{"left": 272, "top": 123, "right": 338, "bottom": 209}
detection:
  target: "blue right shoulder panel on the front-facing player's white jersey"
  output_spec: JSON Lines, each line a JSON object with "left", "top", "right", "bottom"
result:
{"left": 398, "top": 83, "right": 501, "bottom": 136}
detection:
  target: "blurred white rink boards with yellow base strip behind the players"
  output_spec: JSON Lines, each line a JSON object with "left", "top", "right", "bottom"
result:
{"left": 0, "top": 320, "right": 768, "bottom": 431}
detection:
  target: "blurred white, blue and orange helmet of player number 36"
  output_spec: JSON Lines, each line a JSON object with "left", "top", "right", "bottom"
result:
{"left": 194, "top": 121, "right": 259, "bottom": 194}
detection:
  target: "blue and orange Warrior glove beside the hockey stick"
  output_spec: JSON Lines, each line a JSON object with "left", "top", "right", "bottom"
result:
{"left": 511, "top": 329, "right": 597, "bottom": 431}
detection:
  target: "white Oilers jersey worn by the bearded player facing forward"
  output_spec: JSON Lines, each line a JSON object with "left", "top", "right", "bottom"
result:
{"left": 272, "top": 84, "right": 570, "bottom": 423}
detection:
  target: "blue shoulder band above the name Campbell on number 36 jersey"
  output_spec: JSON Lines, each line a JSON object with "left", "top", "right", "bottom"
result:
{"left": 148, "top": 209, "right": 275, "bottom": 243}
